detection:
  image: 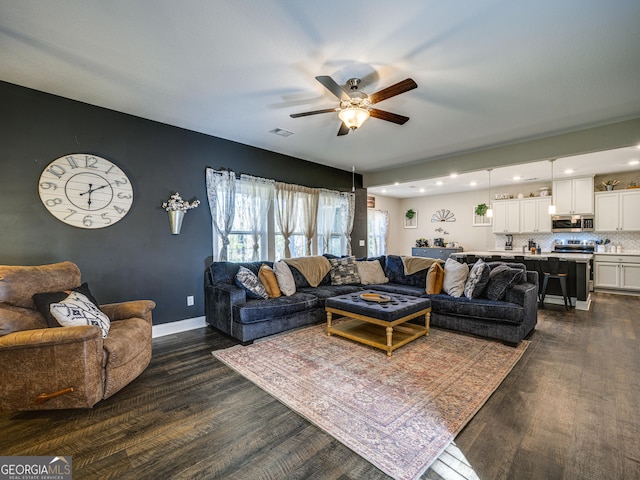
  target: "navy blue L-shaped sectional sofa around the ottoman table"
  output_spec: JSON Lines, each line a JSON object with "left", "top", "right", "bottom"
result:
{"left": 205, "top": 255, "right": 538, "bottom": 345}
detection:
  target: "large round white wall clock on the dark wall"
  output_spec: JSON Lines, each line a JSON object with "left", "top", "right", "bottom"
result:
{"left": 38, "top": 153, "right": 133, "bottom": 228}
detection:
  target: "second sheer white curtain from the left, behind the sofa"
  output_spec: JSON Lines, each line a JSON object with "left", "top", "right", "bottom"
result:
{"left": 240, "top": 175, "right": 276, "bottom": 262}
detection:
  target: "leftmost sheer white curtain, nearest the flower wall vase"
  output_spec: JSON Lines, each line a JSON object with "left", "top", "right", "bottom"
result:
{"left": 206, "top": 168, "right": 236, "bottom": 261}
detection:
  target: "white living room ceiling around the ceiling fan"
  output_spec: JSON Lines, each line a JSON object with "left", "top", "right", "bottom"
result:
{"left": 0, "top": 0, "right": 640, "bottom": 180}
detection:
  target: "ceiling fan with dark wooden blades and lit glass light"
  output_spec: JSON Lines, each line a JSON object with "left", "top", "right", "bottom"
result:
{"left": 291, "top": 75, "right": 418, "bottom": 136}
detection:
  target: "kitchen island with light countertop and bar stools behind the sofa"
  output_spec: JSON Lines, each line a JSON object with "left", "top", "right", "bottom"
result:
{"left": 451, "top": 250, "right": 593, "bottom": 310}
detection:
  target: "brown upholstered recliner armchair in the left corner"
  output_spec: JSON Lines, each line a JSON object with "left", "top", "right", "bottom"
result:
{"left": 0, "top": 262, "right": 155, "bottom": 410}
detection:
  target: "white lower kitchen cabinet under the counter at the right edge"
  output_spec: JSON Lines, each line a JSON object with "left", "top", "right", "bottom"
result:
{"left": 593, "top": 254, "right": 640, "bottom": 291}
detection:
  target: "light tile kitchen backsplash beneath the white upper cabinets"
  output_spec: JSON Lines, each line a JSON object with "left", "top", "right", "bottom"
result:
{"left": 496, "top": 232, "right": 640, "bottom": 252}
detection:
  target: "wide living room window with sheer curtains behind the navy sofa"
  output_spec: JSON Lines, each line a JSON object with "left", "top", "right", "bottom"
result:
{"left": 207, "top": 169, "right": 355, "bottom": 262}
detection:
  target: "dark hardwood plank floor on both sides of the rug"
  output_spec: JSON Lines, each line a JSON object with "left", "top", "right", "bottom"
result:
{"left": 0, "top": 294, "right": 640, "bottom": 480}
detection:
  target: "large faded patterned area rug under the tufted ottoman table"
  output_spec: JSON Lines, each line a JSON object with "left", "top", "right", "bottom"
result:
{"left": 212, "top": 325, "right": 529, "bottom": 480}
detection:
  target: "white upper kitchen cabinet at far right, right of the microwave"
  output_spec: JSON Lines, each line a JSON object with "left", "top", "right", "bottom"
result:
{"left": 595, "top": 189, "right": 640, "bottom": 232}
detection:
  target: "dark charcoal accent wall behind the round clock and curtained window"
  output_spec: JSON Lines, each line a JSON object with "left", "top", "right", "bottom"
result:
{"left": 0, "top": 82, "right": 367, "bottom": 324}
